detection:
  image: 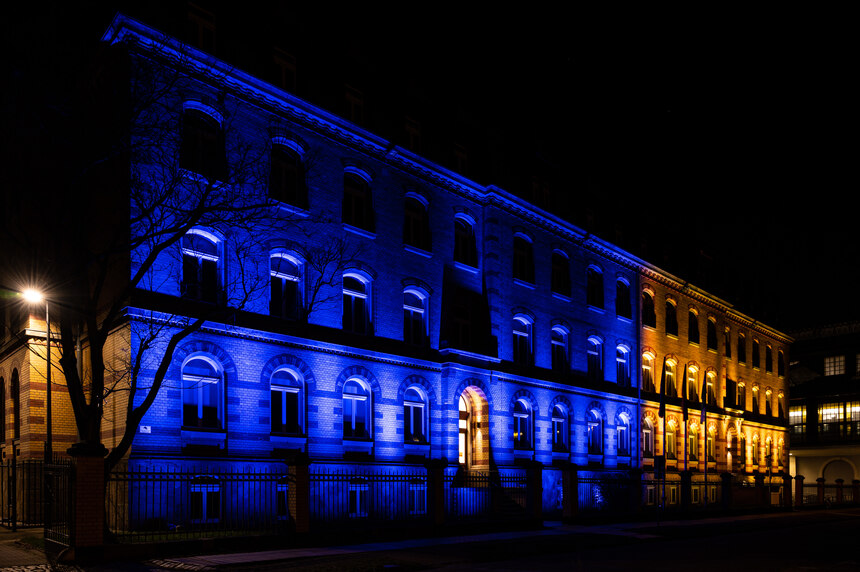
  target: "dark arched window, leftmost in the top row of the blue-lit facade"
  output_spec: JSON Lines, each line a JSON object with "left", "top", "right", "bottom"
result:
{"left": 179, "top": 102, "right": 227, "bottom": 180}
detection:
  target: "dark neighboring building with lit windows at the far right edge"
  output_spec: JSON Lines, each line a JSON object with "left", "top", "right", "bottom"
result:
{"left": 789, "top": 322, "right": 860, "bottom": 485}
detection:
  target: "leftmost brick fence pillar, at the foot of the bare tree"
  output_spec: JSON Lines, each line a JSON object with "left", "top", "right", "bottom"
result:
{"left": 67, "top": 443, "right": 108, "bottom": 563}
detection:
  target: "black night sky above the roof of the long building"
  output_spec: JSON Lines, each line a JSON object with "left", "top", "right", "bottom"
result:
{"left": 7, "top": 2, "right": 860, "bottom": 331}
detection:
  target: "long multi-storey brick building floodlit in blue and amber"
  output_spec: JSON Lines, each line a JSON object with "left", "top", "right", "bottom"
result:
{"left": 0, "top": 8, "right": 791, "bottom": 528}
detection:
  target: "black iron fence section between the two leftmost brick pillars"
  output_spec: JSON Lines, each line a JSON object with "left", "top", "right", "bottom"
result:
{"left": 105, "top": 462, "right": 291, "bottom": 543}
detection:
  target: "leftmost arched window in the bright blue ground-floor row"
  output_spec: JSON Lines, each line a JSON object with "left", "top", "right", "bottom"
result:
{"left": 182, "top": 355, "right": 224, "bottom": 429}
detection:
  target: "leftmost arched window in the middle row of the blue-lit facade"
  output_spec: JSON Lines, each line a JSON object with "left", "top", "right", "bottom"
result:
{"left": 181, "top": 230, "right": 221, "bottom": 304}
